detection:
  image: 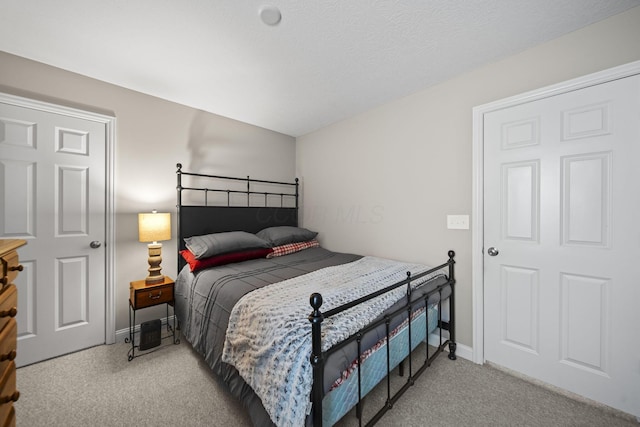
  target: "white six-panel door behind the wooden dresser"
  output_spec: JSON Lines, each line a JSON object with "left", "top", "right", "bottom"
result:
{"left": 0, "top": 98, "right": 107, "bottom": 366}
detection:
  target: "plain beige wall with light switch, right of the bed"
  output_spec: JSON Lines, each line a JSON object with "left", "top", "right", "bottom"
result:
{"left": 297, "top": 7, "right": 640, "bottom": 346}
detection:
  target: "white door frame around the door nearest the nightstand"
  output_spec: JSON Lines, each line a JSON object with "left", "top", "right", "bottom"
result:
{"left": 0, "top": 92, "right": 116, "bottom": 344}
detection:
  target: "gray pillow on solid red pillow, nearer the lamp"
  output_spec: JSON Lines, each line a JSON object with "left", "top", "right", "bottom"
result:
{"left": 184, "top": 231, "right": 271, "bottom": 259}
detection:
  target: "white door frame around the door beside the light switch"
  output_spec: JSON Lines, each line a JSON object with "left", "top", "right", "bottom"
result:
{"left": 471, "top": 61, "right": 640, "bottom": 364}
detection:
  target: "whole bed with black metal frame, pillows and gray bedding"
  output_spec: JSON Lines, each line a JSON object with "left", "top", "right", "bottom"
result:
{"left": 175, "top": 164, "right": 456, "bottom": 426}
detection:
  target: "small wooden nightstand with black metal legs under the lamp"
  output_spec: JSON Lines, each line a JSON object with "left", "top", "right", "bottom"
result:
{"left": 124, "top": 276, "right": 180, "bottom": 361}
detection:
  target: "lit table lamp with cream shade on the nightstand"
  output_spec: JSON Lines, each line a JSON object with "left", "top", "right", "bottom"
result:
{"left": 138, "top": 210, "right": 171, "bottom": 285}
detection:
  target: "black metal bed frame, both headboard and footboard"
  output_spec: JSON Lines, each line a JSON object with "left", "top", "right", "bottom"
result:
{"left": 176, "top": 163, "right": 456, "bottom": 427}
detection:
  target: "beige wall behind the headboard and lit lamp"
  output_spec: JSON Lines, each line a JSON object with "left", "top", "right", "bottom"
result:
{"left": 0, "top": 52, "right": 295, "bottom": 334}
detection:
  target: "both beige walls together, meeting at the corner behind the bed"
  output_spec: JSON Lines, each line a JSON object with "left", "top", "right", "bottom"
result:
{"left": 0, "top": 7, "right": 640, "bottom": 345}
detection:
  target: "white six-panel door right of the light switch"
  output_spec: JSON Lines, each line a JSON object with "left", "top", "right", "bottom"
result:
{"left": 484, "top": 75, "right": 640, "bottom": 416}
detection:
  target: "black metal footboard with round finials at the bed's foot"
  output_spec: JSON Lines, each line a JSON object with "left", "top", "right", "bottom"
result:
{"left": 309, "top": 251, "right": 456, "bottom": 427}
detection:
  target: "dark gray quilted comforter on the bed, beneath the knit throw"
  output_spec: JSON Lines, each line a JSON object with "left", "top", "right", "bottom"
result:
{"left": 175, "top": 248, "right": 361, "bottom": 426}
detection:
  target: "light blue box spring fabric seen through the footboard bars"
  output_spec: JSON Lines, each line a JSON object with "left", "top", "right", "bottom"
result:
{"left": 322, "top": 304, "right": 438, "bottom": 426}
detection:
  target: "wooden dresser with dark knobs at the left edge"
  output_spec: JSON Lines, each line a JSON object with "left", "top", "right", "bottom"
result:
{"left": 0, "top": 240, "right": 26, "bottom": 427}
